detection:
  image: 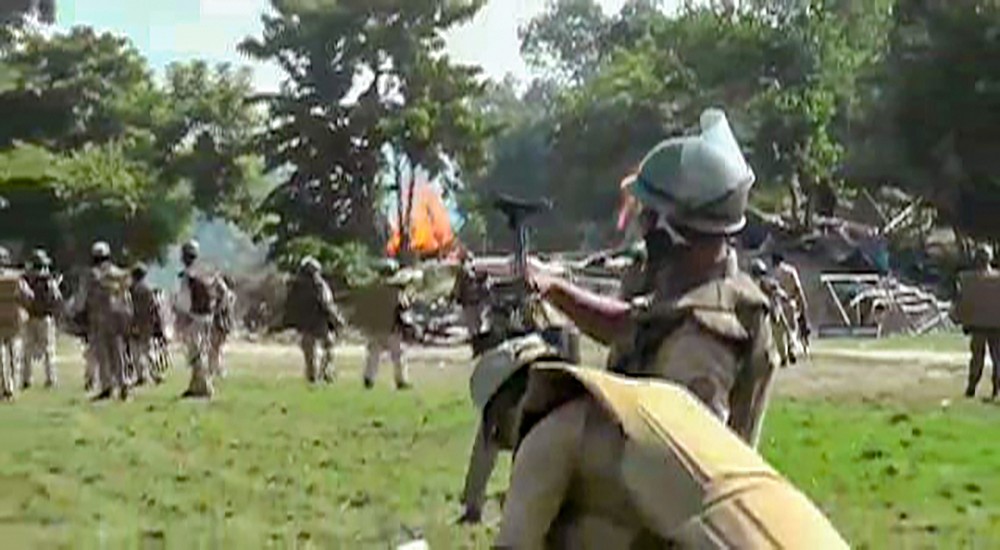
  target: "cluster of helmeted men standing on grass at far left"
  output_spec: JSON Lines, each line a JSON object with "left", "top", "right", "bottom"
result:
{"left": 0, "top": 241, "right": 235, "bottom": 401}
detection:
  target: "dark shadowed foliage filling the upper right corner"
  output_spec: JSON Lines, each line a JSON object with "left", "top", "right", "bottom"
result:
{"left": 852, "top": 0, "right": 1000, "bottom": 239}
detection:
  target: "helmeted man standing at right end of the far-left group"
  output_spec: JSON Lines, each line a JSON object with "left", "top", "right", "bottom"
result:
{"left": 173, "top": 241, "right": 228, "bottom": 399}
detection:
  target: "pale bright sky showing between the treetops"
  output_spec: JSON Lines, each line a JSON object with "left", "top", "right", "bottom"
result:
{"left": 58, "top": 0, "right": 640, "bottom": 90}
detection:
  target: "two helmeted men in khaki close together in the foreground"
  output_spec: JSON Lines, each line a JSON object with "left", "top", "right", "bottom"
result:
{"left": 462, "top": 110, "right": 847, "bottom": 548}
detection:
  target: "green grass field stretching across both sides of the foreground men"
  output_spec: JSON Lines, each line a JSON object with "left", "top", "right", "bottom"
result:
{"left": 0, "top": 336, "right": 1000, "bottom": 548}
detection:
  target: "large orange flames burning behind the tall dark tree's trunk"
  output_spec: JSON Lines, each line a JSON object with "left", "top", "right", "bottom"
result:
{"left": 386, "top": 182, "right": 455, "bottom": 257}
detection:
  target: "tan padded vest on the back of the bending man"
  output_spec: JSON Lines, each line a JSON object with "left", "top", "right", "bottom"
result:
{"left": 521, "top": 366, "right": 848, "bottom": 549}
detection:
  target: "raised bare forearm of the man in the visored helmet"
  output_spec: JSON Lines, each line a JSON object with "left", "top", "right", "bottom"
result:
{"left": 539, "top": 278, "right": 632, "bottom": 346}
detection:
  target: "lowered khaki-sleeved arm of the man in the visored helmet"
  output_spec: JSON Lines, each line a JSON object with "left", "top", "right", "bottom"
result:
{"left": 729, "top": 314, "right": 778, "bottom": 448}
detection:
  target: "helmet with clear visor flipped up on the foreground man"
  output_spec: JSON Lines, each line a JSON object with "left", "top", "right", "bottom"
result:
{"left": 627, "top": 109, "right": 755, "bottom": 235}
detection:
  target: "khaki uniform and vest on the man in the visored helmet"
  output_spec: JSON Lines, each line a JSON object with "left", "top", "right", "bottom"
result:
{"left": 610, "top": 262, "right": 780, "bottom": 446}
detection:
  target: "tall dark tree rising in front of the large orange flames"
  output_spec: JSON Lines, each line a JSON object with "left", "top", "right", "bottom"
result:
{"left": 242, "top": 0, "right": 485, "bottom": 260}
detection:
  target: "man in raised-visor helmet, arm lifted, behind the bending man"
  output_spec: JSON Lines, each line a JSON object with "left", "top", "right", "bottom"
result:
{"left": 533, "top": 110, "right": 779, "bottom": 446}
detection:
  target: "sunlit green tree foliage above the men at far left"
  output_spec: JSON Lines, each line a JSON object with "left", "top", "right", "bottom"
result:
{"left": 0, "top": 27, "right": 268, "bottom": 260}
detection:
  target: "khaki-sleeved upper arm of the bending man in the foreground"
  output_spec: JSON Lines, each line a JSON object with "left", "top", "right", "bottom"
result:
{"left": 494, "top": 399, "right": 589, "bottom": 550}
